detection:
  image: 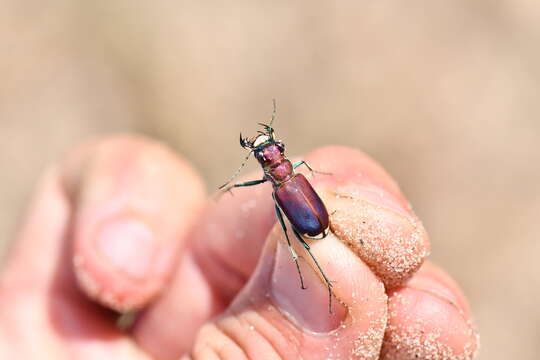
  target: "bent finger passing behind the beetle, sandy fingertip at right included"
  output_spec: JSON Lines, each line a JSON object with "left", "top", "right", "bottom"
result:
{"left": 135, "top": 147, "right": 429, "bottom": 358}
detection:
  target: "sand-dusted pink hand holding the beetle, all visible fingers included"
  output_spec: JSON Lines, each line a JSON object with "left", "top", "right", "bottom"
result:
{"left": 0, "top": 136, "right": 477, "bottom": 359}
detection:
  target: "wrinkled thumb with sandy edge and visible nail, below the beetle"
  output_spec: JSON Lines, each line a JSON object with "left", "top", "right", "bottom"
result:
{"left": 191, "top": 209, "right": 387, "bottom": 359}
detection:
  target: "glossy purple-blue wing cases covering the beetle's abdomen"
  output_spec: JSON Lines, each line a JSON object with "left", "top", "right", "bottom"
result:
{"left": 275, "top": 174, "right": 328, "bottom": 236}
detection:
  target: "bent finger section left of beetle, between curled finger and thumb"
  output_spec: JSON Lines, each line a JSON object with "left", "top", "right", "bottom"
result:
{"left": 133, "top": 173, "right": 276, "bottom": 359}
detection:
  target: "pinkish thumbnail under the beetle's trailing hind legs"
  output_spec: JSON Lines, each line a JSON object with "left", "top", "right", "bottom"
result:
{"left": 271, "top": 240, "right": 347, "bottom": 333}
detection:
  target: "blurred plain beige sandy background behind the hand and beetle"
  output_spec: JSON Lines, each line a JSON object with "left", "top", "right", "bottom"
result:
{"left": 0, "top": 0, "right": 540, "bottom": 360}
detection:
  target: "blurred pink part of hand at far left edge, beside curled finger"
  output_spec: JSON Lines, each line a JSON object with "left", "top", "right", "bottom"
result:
{"left": 0, "top": 168, "right": 152, "bottom": 359}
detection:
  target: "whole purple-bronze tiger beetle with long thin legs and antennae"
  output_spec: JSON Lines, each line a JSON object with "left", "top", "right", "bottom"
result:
{"left": 219, "top": 100, "right": 332, "bottom": 313}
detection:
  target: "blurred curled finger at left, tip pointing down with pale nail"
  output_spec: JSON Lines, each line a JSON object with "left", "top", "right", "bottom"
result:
{"left": 63, "top": 136, "right": 204, "bottom": 311}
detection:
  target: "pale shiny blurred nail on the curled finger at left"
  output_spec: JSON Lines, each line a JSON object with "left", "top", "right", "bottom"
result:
{"left": 95, "top": 217, "right": 155, "bottom": 279}
